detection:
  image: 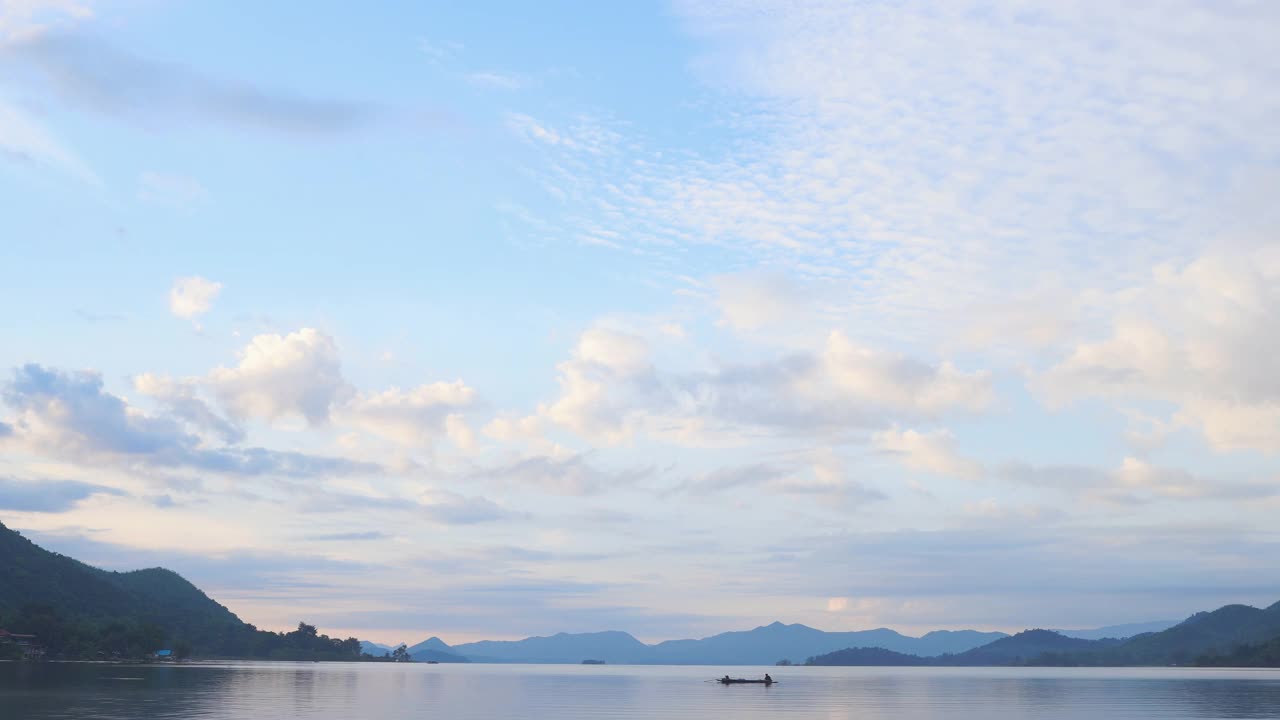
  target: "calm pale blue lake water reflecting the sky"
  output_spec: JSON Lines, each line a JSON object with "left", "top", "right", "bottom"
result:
{"left": 0, "top": 662, "right": 1280, "bottom": 720}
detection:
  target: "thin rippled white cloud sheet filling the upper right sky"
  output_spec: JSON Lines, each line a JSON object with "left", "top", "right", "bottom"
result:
{"left": 512, "top": 0, "right": 1280, "bottom": 346}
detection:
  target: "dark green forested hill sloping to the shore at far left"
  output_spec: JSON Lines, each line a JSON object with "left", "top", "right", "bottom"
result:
{"left": 0, "top": 523, "right": 360, "bottom": 660}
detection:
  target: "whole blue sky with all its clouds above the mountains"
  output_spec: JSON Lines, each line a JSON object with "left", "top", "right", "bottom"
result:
{"left": 0, "top": 0, "right": 1280, "bottom": 642}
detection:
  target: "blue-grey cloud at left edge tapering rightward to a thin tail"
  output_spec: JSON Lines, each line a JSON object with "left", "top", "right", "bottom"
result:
{"left": 0, "top": 364, "right": 379, "bottom": 478}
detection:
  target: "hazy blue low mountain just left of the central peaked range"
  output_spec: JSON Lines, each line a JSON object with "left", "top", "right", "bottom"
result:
{"left": 450, "top": 630, "right": 653, "bottom": 665}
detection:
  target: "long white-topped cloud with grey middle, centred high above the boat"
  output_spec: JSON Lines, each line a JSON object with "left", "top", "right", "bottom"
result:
{"left": 541, "top": 329, "right": 993, "bottom": 443}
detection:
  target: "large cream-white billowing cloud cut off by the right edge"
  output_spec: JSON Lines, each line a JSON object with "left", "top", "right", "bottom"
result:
{"left": 1033, "top": 249, "right": 1280, "bottom": 452}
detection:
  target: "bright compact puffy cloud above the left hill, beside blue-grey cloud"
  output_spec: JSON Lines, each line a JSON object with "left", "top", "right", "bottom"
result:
{"left": 209, "top": 328, "right": 352, "bottom": 425}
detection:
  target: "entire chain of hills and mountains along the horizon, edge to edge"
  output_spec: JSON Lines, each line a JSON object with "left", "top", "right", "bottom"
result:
{"left": 0, "top": 515, "right": 1280, "bottom": 666}
